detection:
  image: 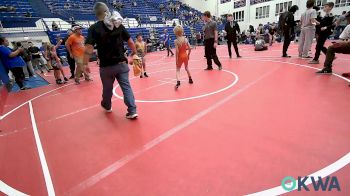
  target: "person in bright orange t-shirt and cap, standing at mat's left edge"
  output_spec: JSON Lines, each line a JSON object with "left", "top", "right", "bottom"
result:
{"left": 66, "top": 26, "right": 92, "bottom": 84}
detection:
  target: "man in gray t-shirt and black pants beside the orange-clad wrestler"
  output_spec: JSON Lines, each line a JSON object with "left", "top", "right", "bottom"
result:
{"left": 202, "top": 11, "right": 222, "bottom": 70}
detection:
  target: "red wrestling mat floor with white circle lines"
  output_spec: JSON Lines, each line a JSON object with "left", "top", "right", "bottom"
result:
{"left": 0, "top": 44, "right": 350, "bottom": 196}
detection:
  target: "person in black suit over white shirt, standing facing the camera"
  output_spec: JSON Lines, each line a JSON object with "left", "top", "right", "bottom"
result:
{"left": 225, "top": 14, "right": 241, "bottom": 58}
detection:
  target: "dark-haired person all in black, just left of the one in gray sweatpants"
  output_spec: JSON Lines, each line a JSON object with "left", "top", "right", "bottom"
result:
{"left": 279, "top": 5, "right": 299, "bottom": 58}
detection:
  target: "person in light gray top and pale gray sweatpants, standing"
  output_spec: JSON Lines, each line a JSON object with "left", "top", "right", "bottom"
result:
{"left": 298, "top": 0, "right": 319, "bottom": 58}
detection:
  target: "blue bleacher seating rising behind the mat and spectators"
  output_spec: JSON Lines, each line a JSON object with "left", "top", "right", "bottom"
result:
{"left": 0, "top": 0, "right": 212, "bottom": 56}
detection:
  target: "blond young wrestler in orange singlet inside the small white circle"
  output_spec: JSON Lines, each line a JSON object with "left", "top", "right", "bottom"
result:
{"left": 174, "top": 26, "right": 193, "bottom": 90}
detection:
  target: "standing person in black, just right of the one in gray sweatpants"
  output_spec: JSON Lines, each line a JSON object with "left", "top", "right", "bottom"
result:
{"left": 309, "top": 2, "right": 335, "bottom": 64}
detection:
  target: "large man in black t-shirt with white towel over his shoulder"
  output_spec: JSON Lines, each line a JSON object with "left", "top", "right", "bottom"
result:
{"left": 84, "top": 2, "right": 138, "bottom": 119}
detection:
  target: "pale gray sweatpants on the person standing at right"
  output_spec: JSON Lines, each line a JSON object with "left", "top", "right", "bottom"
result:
{"left": 298, "top": 28, "right": 316, "bottom": 57}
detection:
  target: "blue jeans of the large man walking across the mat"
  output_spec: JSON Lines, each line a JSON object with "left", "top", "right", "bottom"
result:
{"left": 100, "top": 63, "right": 136, "bottom": 114}
